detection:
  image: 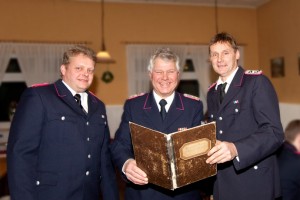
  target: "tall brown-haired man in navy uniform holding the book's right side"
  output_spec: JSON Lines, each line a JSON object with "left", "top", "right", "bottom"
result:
{"left": 207, "top": 33, "right": 284, "bottom": 200}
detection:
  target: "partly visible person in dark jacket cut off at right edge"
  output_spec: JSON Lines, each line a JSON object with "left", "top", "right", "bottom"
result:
{"left": 278, "top": 119, "right": 300, "bottom": 200}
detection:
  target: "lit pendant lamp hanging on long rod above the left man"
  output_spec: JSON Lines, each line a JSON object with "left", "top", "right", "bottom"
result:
{"left": 97, "top": 0, "right": 115, "bottom": 64}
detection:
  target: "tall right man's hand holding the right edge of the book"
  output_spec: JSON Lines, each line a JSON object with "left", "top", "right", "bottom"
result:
{"left": 206, "top": 140, "right": 238, "bottom": 164}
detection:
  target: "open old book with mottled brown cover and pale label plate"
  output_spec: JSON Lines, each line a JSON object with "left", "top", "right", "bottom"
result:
{"left": 129, "top": 122, "right": 217, "bottom": 190}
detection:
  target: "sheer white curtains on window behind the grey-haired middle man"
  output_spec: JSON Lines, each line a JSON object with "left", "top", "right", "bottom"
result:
{"left": 126, "top": 44, "right": 243, "bottom": 112}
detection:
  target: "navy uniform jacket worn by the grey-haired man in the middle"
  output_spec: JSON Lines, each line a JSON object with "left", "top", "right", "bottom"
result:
{"left": 111, "top": 92, "right": 203, "bottom": 200}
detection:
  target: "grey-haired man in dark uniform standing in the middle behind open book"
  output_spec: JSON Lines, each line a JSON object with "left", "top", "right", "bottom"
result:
{"left": 111, "top": 48, "right": 203, "bottom": 200}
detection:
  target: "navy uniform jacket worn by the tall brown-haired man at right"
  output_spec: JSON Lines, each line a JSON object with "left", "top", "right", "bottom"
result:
{"left": 207, "top": 67, "right": 284, "bottom": 200}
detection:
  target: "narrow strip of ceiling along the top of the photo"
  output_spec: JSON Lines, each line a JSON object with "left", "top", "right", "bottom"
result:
{"left": 77, "top": 0, "right": 271, "bottom": 8}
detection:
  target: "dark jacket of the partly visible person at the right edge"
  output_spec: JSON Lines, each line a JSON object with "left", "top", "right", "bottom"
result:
{"left": 278, "top": 142, "right": 300, "bottom": 200}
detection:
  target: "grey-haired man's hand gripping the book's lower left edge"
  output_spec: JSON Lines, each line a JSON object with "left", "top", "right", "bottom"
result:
{"left": 124, "top": 159, "right": 148, "bottom": 185}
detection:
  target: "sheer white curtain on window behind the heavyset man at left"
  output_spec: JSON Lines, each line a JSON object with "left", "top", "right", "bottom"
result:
{"left": 0, "top": 43, "right": 72, "bottom": 86}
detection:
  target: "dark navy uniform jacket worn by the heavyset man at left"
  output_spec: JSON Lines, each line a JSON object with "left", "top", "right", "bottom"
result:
{"left": 7, "top": 80, "right": 118, "bottom": 200}
